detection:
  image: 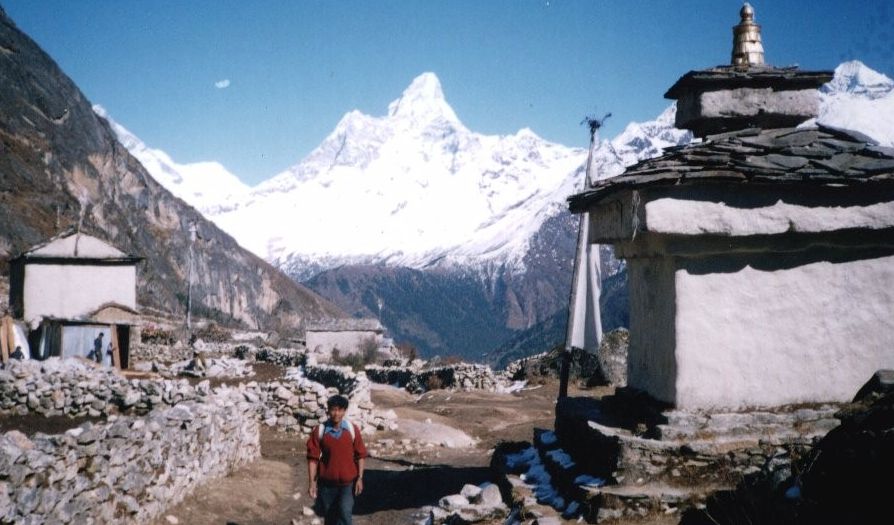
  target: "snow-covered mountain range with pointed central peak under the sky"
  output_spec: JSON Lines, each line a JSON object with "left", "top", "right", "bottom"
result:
{"left": 101, "top": 62, "right": 894, "bottom": 278}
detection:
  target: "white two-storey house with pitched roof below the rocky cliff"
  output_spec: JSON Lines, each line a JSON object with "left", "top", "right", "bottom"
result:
{"left": 9, "top": 232, "right": 141, "bottom": 368}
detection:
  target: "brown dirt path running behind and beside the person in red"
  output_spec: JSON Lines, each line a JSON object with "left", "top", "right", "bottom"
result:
{"left": 155, "top": 378, "right": 558, "bottom": 525}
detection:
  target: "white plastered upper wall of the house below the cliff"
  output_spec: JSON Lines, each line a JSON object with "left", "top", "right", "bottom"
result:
{"left": 24, "top": 264, "right": 137, "bottom": 326}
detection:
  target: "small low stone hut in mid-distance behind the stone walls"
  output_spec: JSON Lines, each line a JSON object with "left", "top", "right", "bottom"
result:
{"left": 305, "top": 318, "right": 385, "bottom": 355}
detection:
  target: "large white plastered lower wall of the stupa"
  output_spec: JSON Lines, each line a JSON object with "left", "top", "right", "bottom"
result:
{"left": 676, "top": 256, "right": 894, "bottom": 409}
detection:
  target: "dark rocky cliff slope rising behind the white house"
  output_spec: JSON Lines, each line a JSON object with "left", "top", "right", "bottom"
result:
{"left": 0, "top": 8, "right": 344, "bottom": 331}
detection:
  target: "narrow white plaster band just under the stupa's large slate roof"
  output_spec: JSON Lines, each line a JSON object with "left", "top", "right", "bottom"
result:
{"left": 645, "top": 197, "right": 894, "bottom": 235}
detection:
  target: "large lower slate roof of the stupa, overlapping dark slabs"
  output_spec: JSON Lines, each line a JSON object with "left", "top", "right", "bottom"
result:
{"left": 568, "top": 126, "right": 894, "bottom": 213}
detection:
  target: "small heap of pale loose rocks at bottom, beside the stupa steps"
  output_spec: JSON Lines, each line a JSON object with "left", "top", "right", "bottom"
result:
{"left": 421, "top": 483, "right": 509, "bottom": 525}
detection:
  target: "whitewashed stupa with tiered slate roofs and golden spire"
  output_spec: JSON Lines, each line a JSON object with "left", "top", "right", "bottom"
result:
{"left": 570, "top": 4, "right": 894, "bottom": 410}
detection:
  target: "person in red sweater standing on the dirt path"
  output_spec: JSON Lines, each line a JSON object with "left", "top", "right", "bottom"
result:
{"left": 307, "top": 395, "right": 366, "bottom": 525}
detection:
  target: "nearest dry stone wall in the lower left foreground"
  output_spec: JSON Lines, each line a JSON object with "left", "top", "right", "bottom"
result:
{"left": 0, "top": 391, "right": 260, "bottom": 523}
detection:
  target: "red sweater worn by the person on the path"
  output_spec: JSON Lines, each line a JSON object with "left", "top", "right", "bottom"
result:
{"left": 307, "top": 423, "right": 366, "bottom": 486}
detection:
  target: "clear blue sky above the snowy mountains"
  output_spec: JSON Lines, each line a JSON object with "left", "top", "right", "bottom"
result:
{"left": 0, "top": 0, "right": 894, "bottom": 185}
